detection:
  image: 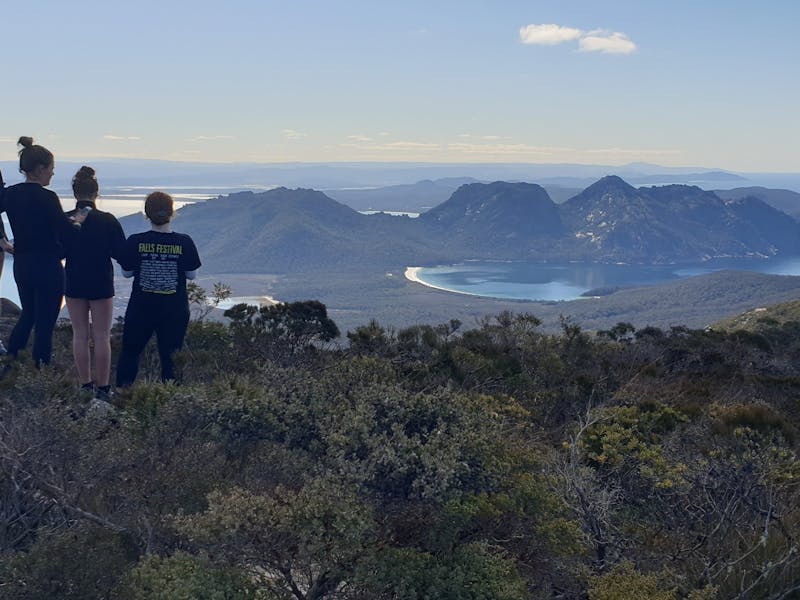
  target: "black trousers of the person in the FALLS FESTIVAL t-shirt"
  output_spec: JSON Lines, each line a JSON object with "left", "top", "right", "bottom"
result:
{"left": 117, "top": 296, "right": 189, "bottom": 387}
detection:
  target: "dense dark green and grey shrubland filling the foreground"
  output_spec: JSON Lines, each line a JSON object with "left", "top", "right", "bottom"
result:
{"left": 0, "top": 292, "right": 800, "bottom": 600}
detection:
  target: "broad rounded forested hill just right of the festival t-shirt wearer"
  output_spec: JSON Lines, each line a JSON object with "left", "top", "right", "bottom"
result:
{"left": 121, "top": 188, "right": 444, "bottom": 273}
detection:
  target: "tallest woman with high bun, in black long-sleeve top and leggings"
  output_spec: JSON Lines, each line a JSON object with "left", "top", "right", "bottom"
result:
{"left": 0, "top": 137, "right": 80, "bottom": 367}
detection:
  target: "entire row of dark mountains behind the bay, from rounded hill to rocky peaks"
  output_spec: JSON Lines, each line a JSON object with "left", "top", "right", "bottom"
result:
{"left": 123, "top": 176, "right": 800, "bottom": 273}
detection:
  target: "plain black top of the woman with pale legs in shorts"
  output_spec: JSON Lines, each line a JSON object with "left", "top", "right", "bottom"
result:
{"left": 65, "top": 201, "right": 125, "bottom": 300}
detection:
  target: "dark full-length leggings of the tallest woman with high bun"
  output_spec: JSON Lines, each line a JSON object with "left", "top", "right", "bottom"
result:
{"left": 8, "top": 254, "right": 64, "bottom": 366}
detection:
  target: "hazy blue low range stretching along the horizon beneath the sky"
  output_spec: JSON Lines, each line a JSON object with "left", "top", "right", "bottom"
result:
{"left": 0, "top": 157, "right": 800, "bottom": 192}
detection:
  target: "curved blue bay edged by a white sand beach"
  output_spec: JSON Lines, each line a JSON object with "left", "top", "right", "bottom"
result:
{"left": 417, "top": 257, "right": 800, "bottom": 301}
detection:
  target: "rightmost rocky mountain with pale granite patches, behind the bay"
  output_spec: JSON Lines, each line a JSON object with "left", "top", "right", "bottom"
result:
{"left": 561, "top": 176, "right": 800, "bottom": 263}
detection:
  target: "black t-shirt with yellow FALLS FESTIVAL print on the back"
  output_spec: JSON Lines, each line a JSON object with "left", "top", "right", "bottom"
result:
{"left": 120, "top": 231, "right": 200, "bottom": 304}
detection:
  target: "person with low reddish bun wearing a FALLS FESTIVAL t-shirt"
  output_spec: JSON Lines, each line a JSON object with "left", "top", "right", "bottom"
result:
{"left": 116, "top": 192, "right": 201, "bottom": 387}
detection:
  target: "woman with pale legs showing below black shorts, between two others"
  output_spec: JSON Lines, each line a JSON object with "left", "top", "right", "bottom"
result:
{"left": 65, "top": 166, "right": 125, "bottom": 401}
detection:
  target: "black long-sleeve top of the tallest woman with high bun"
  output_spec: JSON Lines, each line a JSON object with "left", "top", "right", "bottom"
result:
{"left": 0, "top": 182, "right": 77, "bottom": 258}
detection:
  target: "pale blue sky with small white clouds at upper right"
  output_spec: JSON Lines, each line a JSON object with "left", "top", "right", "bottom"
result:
{"left": 0, "top": 0, "right": 800, "bottom": 172}
